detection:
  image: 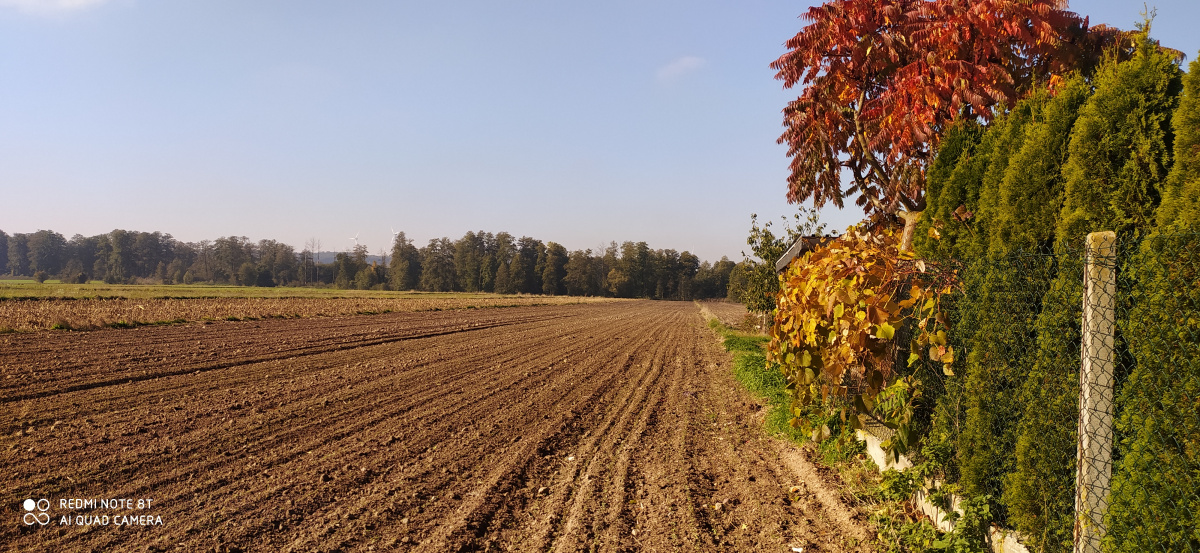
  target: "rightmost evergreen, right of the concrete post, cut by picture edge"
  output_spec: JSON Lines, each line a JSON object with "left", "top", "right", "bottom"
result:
{"left": 1106, "top": 48, "right": 1200, "bottom": 553}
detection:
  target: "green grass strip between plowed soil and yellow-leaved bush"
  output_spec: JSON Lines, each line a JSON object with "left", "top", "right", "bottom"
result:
{"left": 708, "top": 319, "right": 804, "bottom": 443}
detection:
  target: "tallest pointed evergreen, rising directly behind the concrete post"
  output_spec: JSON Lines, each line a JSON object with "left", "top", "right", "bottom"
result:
{"left": 998, "top": 32, "right": 1181, "bottom": 551}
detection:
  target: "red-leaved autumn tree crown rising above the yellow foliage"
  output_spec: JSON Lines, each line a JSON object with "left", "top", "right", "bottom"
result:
{"left": 770, "top": 0, "right": 1123, "bottom": 242}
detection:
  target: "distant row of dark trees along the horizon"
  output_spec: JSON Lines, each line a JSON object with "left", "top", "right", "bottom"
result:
{"left": 0, "top": 230, "right": 748, "bottom": 300}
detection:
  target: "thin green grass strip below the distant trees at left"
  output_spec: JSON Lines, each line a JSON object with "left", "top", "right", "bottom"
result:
{"left": 0, "top": 279, "right": 530, "bottom": 300}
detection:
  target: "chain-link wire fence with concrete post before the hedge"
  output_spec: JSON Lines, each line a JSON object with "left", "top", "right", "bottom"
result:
{"left": 917, "top": 233, "right": 1200, "bottom": 553}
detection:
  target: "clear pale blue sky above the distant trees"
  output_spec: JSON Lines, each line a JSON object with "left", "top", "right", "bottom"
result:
{"left": 0, "top": 0, "right": 1200, "bottom": 260}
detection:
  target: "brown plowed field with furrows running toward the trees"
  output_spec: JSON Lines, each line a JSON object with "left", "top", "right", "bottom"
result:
{"left": 0, "top": 301, "right": 866, "bottom": 553}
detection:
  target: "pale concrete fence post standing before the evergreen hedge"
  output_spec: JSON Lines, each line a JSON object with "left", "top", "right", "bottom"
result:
{"left": 1075, "top": 230, "right": 1117, "bottom": 553}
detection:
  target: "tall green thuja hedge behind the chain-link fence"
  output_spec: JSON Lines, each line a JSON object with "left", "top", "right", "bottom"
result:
{"left": 916, "top": 36, "right": 1200, "bottom": 552}
